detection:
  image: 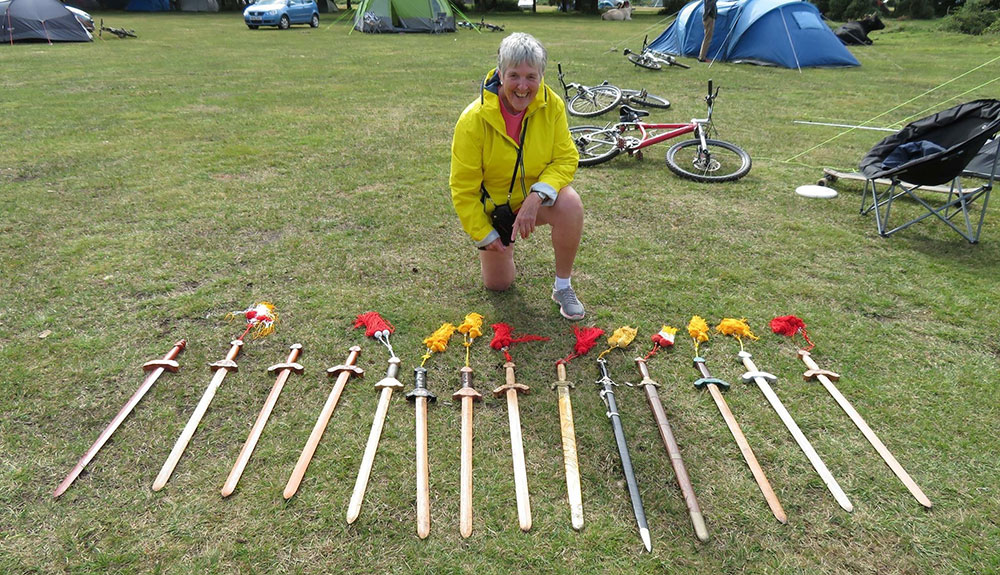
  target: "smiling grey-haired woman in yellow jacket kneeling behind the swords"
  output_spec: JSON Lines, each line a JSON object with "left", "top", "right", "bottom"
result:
{"left": 450, "top": 33, "right": 584, "bottom": 320}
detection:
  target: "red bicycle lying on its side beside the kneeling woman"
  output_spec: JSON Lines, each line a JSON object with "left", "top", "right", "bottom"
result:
{"left": 569, "top": 80, "right": 751, "bottom": 182}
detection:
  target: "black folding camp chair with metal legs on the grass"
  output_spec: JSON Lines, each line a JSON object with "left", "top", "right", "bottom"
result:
{"left": 861, "top": 100, "right": 1000, "bottom": 243}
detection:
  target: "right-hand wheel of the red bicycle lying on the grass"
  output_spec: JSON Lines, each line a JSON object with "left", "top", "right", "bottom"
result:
{"left": 667, "top": 140, "right": 750, "bottom": 182}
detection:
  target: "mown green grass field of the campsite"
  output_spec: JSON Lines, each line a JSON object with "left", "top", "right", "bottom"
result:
{"left": 0, "top": 13, "right": 1000, "bottom": 574}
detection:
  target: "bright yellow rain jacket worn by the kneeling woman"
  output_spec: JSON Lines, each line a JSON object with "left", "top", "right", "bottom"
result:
{"left": 449, "top": 69, "right": 580, "bottom": 247}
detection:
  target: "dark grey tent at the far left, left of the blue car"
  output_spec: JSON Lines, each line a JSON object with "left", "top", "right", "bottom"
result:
{"left": 0, "top": 0, "right": 94, "bottom": 44}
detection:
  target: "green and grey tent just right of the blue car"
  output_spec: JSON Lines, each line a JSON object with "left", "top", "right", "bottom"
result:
{"left": 354, "top": 0, "right": 455, "bottom": 33}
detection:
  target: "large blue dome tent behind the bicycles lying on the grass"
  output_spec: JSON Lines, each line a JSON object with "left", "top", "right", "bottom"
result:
{"left": 649, "top": 0, "right": 860, "bottom": 68}
